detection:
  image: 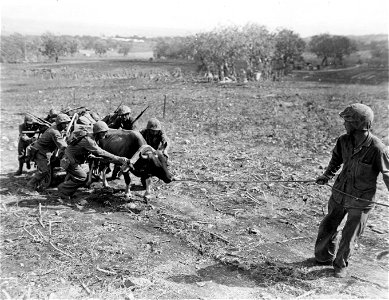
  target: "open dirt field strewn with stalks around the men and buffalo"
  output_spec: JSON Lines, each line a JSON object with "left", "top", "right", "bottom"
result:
{"left": 0, "top": 60, "right": 389, "bottom": 299}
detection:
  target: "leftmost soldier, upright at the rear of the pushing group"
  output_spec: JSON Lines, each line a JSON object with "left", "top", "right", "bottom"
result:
{"left": 15, "top": 115, "right": 40, "bottom": 176}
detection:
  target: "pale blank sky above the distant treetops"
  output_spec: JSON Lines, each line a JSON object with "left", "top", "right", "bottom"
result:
{"left": 1, "top": 0, "right": 389, "bottom": 37}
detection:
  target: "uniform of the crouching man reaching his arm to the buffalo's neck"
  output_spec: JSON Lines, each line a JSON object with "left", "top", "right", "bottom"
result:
{"left": 58, "top": 132, "right": 119, "bottom": 196}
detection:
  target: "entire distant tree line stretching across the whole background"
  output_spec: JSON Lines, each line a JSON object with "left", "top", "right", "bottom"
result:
{"left": 1, "top": 24, "right": 389, "bottom": 71}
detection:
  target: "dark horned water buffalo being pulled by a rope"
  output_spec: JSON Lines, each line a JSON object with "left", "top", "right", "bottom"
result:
{"left": 91, "top": 129, "right": 173, "bottom": 198}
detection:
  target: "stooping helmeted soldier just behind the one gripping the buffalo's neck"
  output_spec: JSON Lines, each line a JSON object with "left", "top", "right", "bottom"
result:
{"left": 27, "top": 114, "right": 70, "bottom": 188}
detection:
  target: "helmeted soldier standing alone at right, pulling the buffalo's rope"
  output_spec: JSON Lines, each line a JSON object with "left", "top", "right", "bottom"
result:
{"left": 315, "top": 103, "right": 389, "bottom": 277}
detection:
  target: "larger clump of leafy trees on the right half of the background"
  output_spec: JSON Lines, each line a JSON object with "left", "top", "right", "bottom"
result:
{"left": 154, "top": 24, "right": 388, "bottom": 80}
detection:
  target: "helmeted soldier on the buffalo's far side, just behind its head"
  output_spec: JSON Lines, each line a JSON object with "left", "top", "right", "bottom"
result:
{"left": 140, "top": 118, "right": 169, "bottom": 157}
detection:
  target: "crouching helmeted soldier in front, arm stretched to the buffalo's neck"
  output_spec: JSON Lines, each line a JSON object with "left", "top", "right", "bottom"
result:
{"left": 58, "top": 121, "right": 127, "bottom": 198}
